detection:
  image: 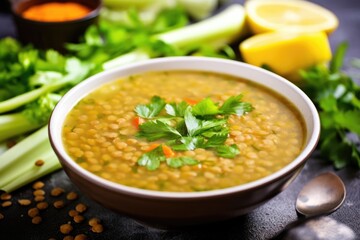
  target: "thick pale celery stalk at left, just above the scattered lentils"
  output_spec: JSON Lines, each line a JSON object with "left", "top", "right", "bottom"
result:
{"left": 0, "top": 126, "right": 61, "bottom": 192}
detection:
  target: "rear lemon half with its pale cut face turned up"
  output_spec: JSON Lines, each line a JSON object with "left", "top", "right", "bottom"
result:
{"left": 245, "top": 0, "right": 339, "bottom": 34}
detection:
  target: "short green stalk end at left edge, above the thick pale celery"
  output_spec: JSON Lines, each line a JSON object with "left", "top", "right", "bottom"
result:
{"left": 0, "top": 113, "right": 41, "bottom": 142}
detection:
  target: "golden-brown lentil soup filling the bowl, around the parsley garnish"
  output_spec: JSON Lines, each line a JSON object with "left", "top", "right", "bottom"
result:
{"left": 63, "top": 71, "right": 305, "bottom": 192}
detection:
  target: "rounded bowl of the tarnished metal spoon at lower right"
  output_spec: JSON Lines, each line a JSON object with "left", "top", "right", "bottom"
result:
{"left": 296, "top": 172, "right": 346, "bottom": 217}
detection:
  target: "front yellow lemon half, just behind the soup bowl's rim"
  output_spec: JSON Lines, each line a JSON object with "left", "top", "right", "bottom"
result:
{"left": 239, "top": 32, "right": 331, "bottom": 80}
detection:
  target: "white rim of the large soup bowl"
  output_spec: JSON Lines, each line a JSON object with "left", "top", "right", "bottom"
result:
{"left": 48, "top": 56, "right": 320, "bottom": 199}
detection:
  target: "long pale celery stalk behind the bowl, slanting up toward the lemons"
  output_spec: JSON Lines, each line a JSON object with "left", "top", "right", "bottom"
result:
{"left": 103, "top": 4, "right": 245, "bottom": 70}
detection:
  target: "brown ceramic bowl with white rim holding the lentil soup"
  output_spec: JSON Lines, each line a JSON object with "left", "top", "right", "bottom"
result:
{"left": 49, "top": 57, "right": 320, "bottom": 228}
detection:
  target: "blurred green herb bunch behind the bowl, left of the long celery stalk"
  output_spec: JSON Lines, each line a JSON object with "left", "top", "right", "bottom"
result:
{"left": 66, "top": 8, "right": 188, "bottom": 72}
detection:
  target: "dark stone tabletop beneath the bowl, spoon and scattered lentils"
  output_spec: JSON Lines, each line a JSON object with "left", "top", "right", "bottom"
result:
{"left": 0, "top": 0, "right": 360, "bottom": 240}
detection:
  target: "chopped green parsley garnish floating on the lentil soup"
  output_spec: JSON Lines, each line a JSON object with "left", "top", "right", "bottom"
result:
{"left": 135, "top": 94, "right": 253, "bottom": 170}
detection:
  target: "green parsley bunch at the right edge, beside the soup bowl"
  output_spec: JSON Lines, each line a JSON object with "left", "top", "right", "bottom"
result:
{"left": 301, "top": 43, "right": 360, "bottom": 168}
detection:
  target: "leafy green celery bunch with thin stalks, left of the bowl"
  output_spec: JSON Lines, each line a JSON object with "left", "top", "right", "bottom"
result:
{"left": 0, "top": 37, "right": 92, "bottom": 141}
